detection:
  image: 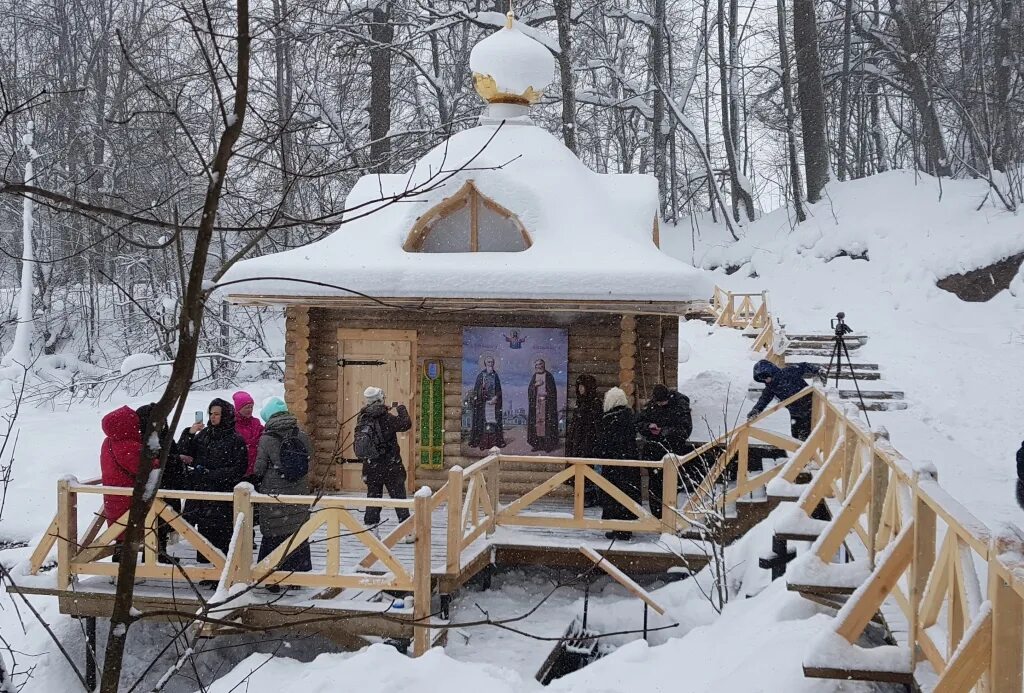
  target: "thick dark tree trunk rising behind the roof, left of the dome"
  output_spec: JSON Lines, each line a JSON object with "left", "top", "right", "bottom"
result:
{"left": 370, "top": 3, "right": 394, "bottom": 173}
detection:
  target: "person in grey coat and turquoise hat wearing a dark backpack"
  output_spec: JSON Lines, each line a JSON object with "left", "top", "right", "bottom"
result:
{"left": 253, "top": 397, "right": 313, "bottom": 577}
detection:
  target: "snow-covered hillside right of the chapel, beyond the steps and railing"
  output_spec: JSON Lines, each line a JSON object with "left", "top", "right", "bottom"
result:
{"left": 663, "top": 171, "right": 1024, "bottom": 526}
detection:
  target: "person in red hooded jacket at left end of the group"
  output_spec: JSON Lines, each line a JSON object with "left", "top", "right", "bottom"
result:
{"left": 99, "top": 406, "right": 160, "bottom": 561}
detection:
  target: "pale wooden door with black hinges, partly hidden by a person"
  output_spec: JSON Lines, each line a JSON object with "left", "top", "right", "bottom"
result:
{"left": 338, "top": 329, "right": 416, "bottom": 490}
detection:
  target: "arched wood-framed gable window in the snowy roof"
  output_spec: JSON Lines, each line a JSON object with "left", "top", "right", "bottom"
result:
{"left": 402, "top": 181, "right": 532, "bottom": 253}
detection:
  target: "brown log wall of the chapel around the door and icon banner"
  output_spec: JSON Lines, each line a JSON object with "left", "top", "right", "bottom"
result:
{"left": 299, "top": 308, "right": 679, "bottom": 492}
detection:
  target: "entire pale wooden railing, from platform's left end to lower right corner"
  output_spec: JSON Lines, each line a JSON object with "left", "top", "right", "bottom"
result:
{"left": 24, "top": 387, "right": 1024, "bottom": 679}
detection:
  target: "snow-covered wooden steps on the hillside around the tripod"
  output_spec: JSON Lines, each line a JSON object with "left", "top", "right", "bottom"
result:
{"left": 748, "top": 334, "right": 907, "bottom": 412}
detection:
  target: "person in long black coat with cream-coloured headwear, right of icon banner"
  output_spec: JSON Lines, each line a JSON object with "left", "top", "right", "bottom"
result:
{"left": 594, "top": 387, "right": 641, "bottom": 539}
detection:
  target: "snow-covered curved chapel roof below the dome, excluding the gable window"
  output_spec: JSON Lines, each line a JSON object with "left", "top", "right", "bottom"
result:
{"left": 222, "top": 114, "right": 712, "bottom": 303}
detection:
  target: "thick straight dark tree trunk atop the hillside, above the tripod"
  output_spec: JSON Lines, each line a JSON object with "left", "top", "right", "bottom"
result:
{"left": 793, "top": 0, "right": 828, "bottom": 204}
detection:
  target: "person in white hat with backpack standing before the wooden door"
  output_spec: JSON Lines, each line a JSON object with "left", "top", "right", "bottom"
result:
{"left": 352, "top": 386, "right": 416, "bottom": 542}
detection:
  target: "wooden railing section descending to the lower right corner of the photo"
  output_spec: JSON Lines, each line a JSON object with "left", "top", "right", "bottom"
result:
{"left": 774, "top": 390, "right": 1024, "bottom": 691}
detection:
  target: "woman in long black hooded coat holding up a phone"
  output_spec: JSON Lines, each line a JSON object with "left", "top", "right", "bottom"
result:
{"left": 178, "top": 398, "right": 249, "bottom": 563}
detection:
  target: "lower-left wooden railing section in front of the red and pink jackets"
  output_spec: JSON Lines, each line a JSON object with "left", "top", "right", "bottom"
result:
{"left": 29, "top": 479, "right": 432, "bottom": 654}
